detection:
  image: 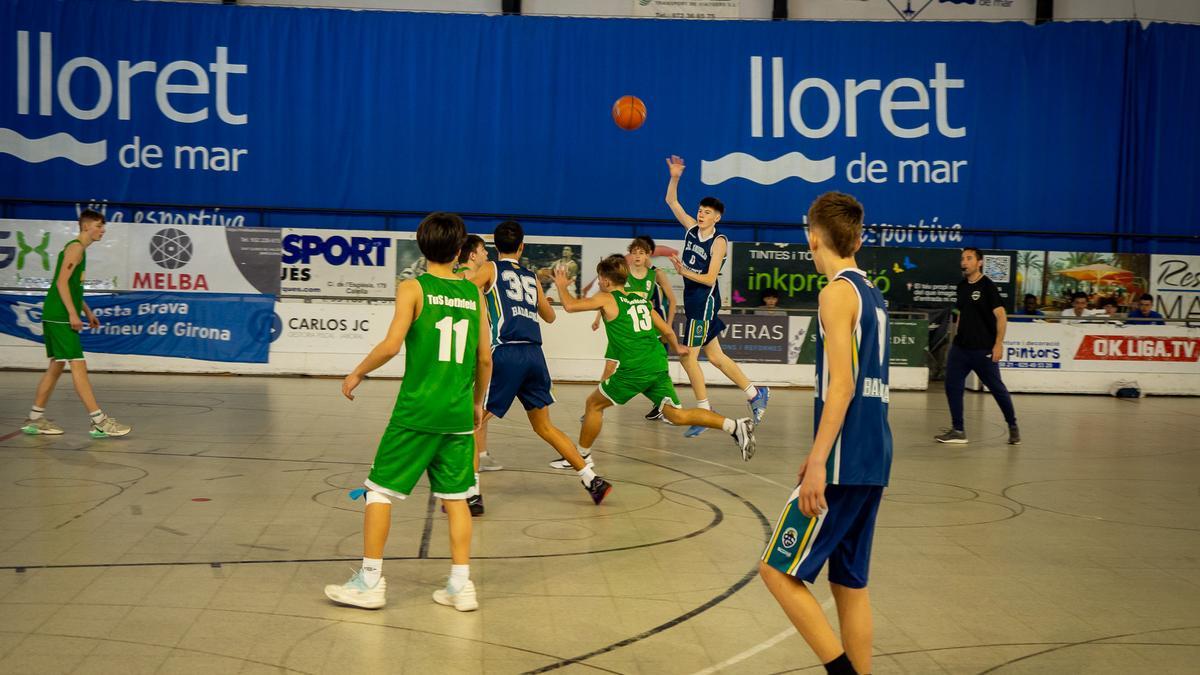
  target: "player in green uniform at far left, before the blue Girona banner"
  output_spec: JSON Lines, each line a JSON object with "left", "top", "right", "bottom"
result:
{"left": 20, "top": 209, "right": 130, "bottom": 438}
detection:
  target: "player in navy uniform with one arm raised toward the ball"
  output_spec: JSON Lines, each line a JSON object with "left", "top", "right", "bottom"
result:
{"left": 667, "top": 155, "right": 770, "bottom": 437}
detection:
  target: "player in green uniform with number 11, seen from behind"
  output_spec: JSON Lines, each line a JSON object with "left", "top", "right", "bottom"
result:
{"left": 325, "top": 213, "right": 492, "bottom": 611}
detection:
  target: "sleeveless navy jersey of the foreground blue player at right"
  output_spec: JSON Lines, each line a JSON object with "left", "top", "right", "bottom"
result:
{"left": 812, "top": 269, "right": 892, "bottom": 485}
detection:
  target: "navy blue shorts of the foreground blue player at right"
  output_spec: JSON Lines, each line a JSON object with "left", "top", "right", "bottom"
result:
{"left": 762, "top": 485, "right": 883, "bottom": 589}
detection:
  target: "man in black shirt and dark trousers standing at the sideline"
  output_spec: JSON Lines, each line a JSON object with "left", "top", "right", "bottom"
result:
{"left": 934, "top": 246, "right": 1021, "bottom": 446}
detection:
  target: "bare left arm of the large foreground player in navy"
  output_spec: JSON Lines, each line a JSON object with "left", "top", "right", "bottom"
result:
{"left": 799, "top": 281, "right": 858, "bottom": 518}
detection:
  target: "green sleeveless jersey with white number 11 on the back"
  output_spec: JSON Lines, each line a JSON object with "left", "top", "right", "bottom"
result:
{"left": 391, "top": 273, "right": 480, "bottom": 434}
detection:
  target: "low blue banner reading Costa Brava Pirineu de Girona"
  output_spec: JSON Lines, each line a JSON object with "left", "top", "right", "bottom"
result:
{"left": 0, "top": 293, "right": 275, "bottom": 363}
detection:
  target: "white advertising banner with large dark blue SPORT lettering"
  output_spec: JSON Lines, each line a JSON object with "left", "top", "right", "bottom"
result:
{"left": 280, "top": 228, "right": 393, "bottom": 298}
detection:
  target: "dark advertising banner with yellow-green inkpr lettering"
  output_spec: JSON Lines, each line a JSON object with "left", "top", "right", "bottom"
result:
{"left": 732, "top": 243, "right": 1015, "bottom": 311}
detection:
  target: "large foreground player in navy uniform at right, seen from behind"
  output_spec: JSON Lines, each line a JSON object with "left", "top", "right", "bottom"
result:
{"left": 760, "top": 192, "right": 892, "bottom": 674}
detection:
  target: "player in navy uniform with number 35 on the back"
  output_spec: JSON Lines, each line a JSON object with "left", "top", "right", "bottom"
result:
{"left": 473, "top": 220, "right": 612, "bottom": 513}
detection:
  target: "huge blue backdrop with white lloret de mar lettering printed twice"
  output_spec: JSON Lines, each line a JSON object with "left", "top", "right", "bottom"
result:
{"left": 0, "top": 0, "right": 1200, "bottom": 247}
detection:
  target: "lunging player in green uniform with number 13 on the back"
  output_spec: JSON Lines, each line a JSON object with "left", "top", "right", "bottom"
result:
{"left": 554, "top": 255, "right": 755, "bottom": 461}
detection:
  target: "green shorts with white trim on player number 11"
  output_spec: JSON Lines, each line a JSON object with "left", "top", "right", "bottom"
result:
{"left": 364, "top": 423, "right": 475, "bottom": 500}
